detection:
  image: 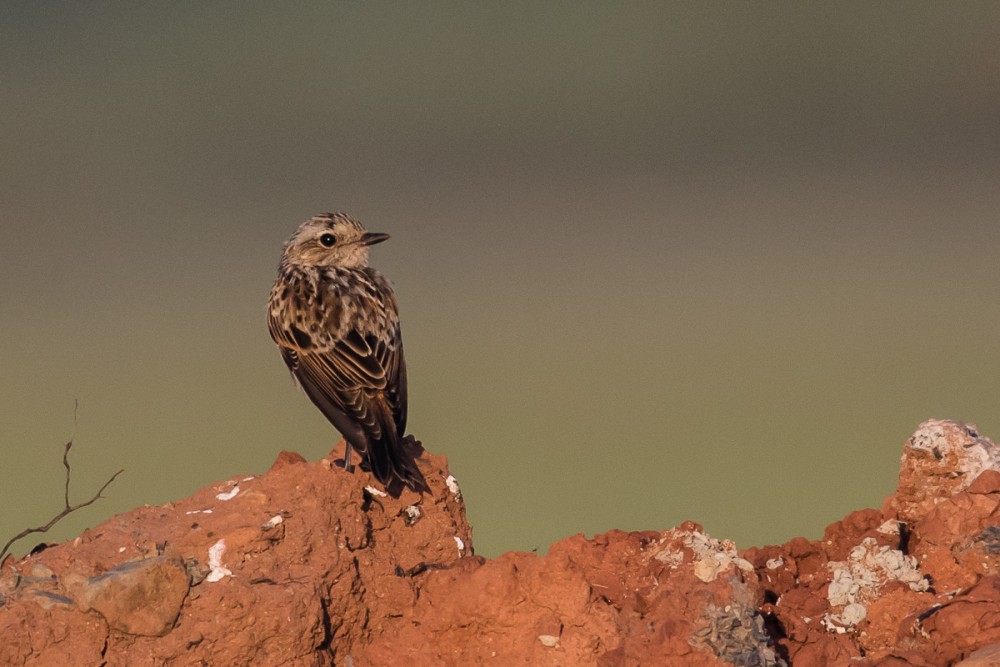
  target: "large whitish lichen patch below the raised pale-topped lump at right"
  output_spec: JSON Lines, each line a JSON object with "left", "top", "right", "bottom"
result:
{"left": 823, "top": 537, "right": 929, "bottom": 632}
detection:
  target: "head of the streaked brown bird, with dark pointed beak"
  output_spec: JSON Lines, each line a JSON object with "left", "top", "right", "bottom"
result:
{"left": 281, "top": 213, "right": 389, "bottom": 269}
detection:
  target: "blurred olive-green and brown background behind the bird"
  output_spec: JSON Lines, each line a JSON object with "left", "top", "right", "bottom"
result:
{"left": 0, "top": 1, "right": 1000, "bottom": 556}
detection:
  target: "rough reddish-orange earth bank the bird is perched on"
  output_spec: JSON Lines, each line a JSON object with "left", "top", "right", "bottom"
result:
{"left": 0, "top": 420, "right": 1000, "bottom": 667}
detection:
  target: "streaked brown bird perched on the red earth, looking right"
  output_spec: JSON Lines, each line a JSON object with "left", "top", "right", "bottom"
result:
{"left": 267, "top": 213, "right": 427, "bottom": 497}
